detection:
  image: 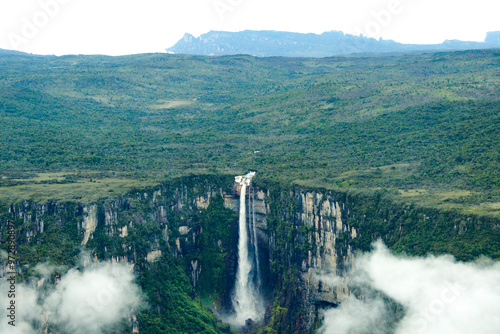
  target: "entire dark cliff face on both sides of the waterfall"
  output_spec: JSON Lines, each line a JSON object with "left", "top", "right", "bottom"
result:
{"left": 0, "top": 177, "right": 499, "bottom": 333}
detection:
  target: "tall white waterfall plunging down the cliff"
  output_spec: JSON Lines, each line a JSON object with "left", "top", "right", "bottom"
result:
{"left": 232, "top": 172, "right": 265, "bottom": 326}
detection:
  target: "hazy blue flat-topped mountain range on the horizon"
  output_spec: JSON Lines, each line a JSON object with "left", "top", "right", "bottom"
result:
{"left": 166, "top": 30, "right": 500, "bottom": 57}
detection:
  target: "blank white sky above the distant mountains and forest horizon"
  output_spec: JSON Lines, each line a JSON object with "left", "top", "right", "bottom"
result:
{"left": 0, "top": 0, "right": 500, "bottom": 55}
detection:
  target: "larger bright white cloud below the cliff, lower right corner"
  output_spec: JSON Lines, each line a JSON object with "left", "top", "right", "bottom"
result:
{"left": 320, "top": 241, "right": 500, "bottom": 334}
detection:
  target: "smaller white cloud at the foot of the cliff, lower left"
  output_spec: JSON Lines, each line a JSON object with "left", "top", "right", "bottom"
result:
{"left": 0, "top": 263, "right": 142, "bottom": 334}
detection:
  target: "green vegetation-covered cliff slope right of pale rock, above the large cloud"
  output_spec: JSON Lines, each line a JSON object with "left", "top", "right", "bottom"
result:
{"left": 334, "top": 193, "right": 500, "bottom": 261}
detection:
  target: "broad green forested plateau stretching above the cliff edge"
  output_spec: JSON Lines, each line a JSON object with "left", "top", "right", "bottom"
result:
{"left": 0, "top": 50, "right": 500, "bottom": 216}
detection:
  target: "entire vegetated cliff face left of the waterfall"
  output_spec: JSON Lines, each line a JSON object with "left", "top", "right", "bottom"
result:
{"left": 0, "top": 177, "right": 237, "bottom": 333}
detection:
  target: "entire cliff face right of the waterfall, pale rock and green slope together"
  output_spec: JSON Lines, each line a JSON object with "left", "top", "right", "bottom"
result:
{"left": 263, "top": 184, "right": 500, "bottom": 333}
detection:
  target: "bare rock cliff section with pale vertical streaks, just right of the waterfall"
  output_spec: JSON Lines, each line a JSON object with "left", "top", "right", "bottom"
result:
{"left": 266, "top": 189, "right": 357, "bottom": 333}
